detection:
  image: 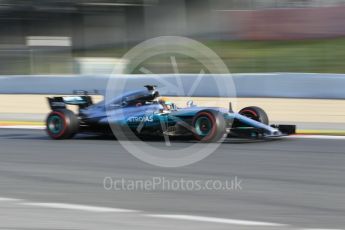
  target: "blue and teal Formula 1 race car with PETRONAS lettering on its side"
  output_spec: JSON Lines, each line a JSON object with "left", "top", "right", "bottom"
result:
{"left": 46, "top": 85, "right": 296, "bottom": 142}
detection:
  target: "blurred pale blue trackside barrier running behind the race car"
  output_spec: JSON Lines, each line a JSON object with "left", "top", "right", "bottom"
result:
{"left": 0, "top": 73, "right": 345, "bottom": 99}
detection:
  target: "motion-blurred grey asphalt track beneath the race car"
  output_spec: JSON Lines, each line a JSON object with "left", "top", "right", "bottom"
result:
{"left": 0, "top": 129, "right": 345, "bottom": 230}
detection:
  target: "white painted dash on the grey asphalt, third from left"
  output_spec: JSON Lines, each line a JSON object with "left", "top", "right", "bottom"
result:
{"left": 144, "top": 214, "right": 286, "bottom": 227}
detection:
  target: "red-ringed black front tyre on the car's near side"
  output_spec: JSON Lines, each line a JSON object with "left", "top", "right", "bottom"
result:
{"left": 192, "top": 110, "right": 226, "bottom": 142}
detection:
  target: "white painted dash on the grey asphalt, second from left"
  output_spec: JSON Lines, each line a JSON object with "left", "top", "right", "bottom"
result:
{"left": 20, "top": 203, "right": 140, "bottom": 212}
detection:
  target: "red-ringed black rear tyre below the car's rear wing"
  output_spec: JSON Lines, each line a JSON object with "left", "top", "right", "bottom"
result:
{"left": 46, "top": 109, "right": 79, "bottom": 140}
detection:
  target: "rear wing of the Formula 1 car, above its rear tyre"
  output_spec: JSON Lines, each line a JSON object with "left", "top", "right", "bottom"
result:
{"left": 47, "top": 96, "right": 93, "bottom": 110}
